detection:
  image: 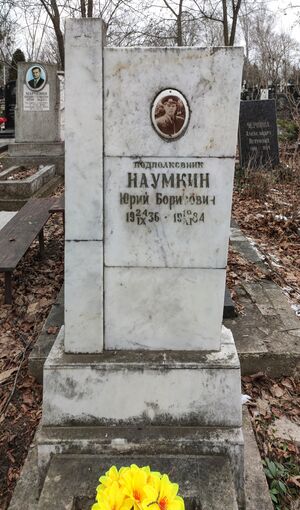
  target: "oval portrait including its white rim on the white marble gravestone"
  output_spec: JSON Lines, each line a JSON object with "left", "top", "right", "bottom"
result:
{"left": 151, "top": 89, "right": 190, "bottom": 140}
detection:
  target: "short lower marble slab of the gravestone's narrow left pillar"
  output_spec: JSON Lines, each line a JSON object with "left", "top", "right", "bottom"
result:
{"left": 65, "top": 241, "right": 103, "bottom": 353}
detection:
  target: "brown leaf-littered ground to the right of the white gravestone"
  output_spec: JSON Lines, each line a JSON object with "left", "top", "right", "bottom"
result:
{"left": 227, "top": 154, "right": 300, "bottom": 510}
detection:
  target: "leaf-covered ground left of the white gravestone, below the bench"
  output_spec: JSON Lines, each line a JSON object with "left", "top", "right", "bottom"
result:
{"left": 0, "top": 189, "right": 64, "bottom": 510}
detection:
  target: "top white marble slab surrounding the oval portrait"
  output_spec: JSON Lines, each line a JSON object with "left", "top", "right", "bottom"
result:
{"left": 104, "top": 47, "right": 244, "bottom": 157}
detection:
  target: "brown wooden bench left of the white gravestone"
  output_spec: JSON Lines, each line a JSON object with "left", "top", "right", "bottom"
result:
{"left": 0, "top": 197, "right": 55, "bottom": 304}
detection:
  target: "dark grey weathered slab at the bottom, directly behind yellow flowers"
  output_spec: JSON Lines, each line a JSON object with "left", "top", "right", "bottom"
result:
{"left": 37, "top": 454, "right": 238, "bottom": 510}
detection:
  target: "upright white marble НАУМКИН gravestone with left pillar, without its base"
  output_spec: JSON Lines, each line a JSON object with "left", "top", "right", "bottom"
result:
{"left": 65, "top": 23, "right": 242, "bottom": 352}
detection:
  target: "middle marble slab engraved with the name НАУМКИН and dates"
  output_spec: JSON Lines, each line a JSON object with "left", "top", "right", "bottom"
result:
{"left": 104, "top": 157, "right": 234, "bottom": 268}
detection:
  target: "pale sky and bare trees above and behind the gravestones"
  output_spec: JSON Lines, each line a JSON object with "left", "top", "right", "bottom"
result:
{"left": 0, "top": 0, "right": 299, "bottom": 80}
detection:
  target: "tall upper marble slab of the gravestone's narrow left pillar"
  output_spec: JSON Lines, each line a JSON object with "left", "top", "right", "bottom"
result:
{"left": 65, "top": 19, "right": 103, "bottom": 241}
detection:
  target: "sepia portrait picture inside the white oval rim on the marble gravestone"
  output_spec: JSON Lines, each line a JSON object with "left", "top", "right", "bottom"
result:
{"left": 155, "top": 95, "right": 185, "bottom": 137}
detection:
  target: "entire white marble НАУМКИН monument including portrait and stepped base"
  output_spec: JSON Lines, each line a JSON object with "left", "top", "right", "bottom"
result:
{"left": 39, "top": 19, "right": 244, "bottom": 510}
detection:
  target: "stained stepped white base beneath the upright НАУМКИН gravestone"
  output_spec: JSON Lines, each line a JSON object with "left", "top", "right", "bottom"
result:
{"left": 38, "top": 328, "right": 243, "bottom": 508}
